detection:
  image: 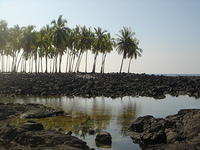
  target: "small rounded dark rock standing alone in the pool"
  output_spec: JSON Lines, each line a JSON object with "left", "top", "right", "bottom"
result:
{"left": 95, "top": 132, "right": 112, "bottom": 146}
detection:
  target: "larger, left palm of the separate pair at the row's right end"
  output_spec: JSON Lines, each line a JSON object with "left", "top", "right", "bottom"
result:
{"left": 116, "top": 27, "right": 141, "bottom": 73}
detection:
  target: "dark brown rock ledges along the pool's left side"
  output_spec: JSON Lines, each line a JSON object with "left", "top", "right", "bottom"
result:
{"left": 0, "top": 104, "right": 90, "bottom": 150}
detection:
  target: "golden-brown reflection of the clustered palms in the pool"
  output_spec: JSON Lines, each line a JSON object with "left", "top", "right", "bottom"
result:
{"left": 31, "top": 98, "right": 112, "bottom": 138}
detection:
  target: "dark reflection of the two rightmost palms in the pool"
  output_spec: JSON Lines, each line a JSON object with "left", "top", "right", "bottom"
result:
{"left": 118, "top": 101, "right": 136, "bottom": 136}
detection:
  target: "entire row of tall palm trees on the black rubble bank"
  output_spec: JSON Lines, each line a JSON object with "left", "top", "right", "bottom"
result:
{"left": 0, "top": 15, "right": 142, "bottom": 73}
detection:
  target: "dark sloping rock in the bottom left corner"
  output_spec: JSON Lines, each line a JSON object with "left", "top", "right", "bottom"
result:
{"left": 0, "top": 122, "right": 92, "bottom": 150}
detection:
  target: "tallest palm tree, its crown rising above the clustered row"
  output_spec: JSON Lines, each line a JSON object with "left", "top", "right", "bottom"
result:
{"left": 51, "top": 15, "right": 69, "bottom": 72}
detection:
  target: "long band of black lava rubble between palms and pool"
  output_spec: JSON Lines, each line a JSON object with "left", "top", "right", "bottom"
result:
{"left": 0, "top": 73, "right": 200, "bottom": 98}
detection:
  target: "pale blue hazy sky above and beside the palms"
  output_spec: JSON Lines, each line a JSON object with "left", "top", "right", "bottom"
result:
{"left": 0, "top": 0, "right": 200, "bottom": 73}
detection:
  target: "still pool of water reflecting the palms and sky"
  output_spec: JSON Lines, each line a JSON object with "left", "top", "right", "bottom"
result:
{"left": 0, "top": 95, "right": 200, "bottom": 150}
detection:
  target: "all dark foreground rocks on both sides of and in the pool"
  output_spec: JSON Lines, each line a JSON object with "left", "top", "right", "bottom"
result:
{"left": 0, "top": 103, "right": 200, "bottom": 150}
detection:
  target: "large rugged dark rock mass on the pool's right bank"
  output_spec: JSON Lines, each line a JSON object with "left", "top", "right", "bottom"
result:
{"left": 130, "top": 109, "right": 200, "bottom": 150}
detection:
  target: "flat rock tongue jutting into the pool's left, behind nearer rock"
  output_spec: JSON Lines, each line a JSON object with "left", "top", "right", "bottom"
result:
{"left": 0, "top": 103, "right": 64, "bottom": 120}
